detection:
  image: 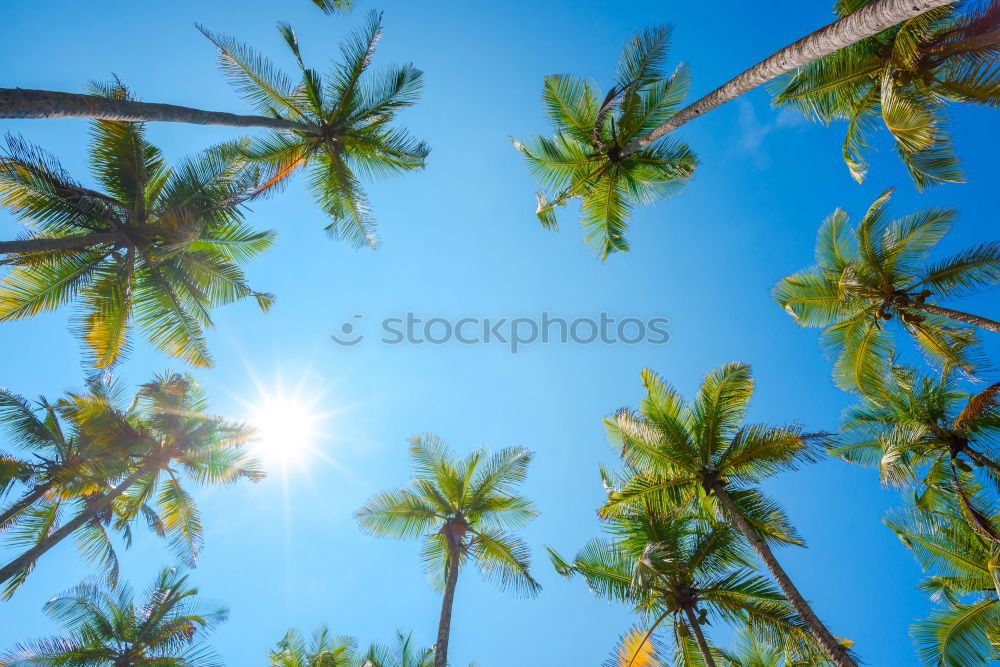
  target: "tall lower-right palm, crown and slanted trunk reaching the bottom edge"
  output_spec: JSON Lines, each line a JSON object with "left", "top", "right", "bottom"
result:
{"left": 601, "top": 363, "right": 855, "bottom": 667}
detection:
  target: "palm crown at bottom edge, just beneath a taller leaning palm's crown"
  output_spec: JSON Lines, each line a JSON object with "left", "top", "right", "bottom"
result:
{"left": 549, "top": 506, "right": 820, "bottom": 667}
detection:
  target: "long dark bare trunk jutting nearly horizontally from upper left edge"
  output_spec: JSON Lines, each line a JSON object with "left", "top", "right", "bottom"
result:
{"left": 0, "top": 88, "right": 319, "bottom": 134}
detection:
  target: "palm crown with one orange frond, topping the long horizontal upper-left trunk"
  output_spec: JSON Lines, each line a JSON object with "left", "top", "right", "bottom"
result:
{"left": 199, "top": 11, "right": 430, "bottom": 248}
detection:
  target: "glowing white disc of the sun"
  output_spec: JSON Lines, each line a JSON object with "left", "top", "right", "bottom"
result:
{"left": 250, "top": 396, "right": 321, "bottom": 462}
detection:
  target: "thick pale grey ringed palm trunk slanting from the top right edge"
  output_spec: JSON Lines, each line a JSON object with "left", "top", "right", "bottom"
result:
{"left": 623, "top": 0, "right": 953, "bottom": 155}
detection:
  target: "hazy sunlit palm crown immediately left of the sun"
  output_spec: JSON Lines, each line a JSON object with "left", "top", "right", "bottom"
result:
{"left": 4, "top": 373, "right": 264, "bottom": 597}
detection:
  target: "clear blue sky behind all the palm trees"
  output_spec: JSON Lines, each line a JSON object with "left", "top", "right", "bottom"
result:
{"left": 0, "top": 0, "right": 1000, "bottom": 667}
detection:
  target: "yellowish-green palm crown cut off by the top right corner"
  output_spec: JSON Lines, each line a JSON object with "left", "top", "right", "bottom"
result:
{"left": 774, "top": 0, "right": 1000, "bottom": 190}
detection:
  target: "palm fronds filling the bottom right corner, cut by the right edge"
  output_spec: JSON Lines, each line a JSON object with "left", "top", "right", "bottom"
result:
{"left": 886, "top": 488, "right": 1000, "bottom": 667}
